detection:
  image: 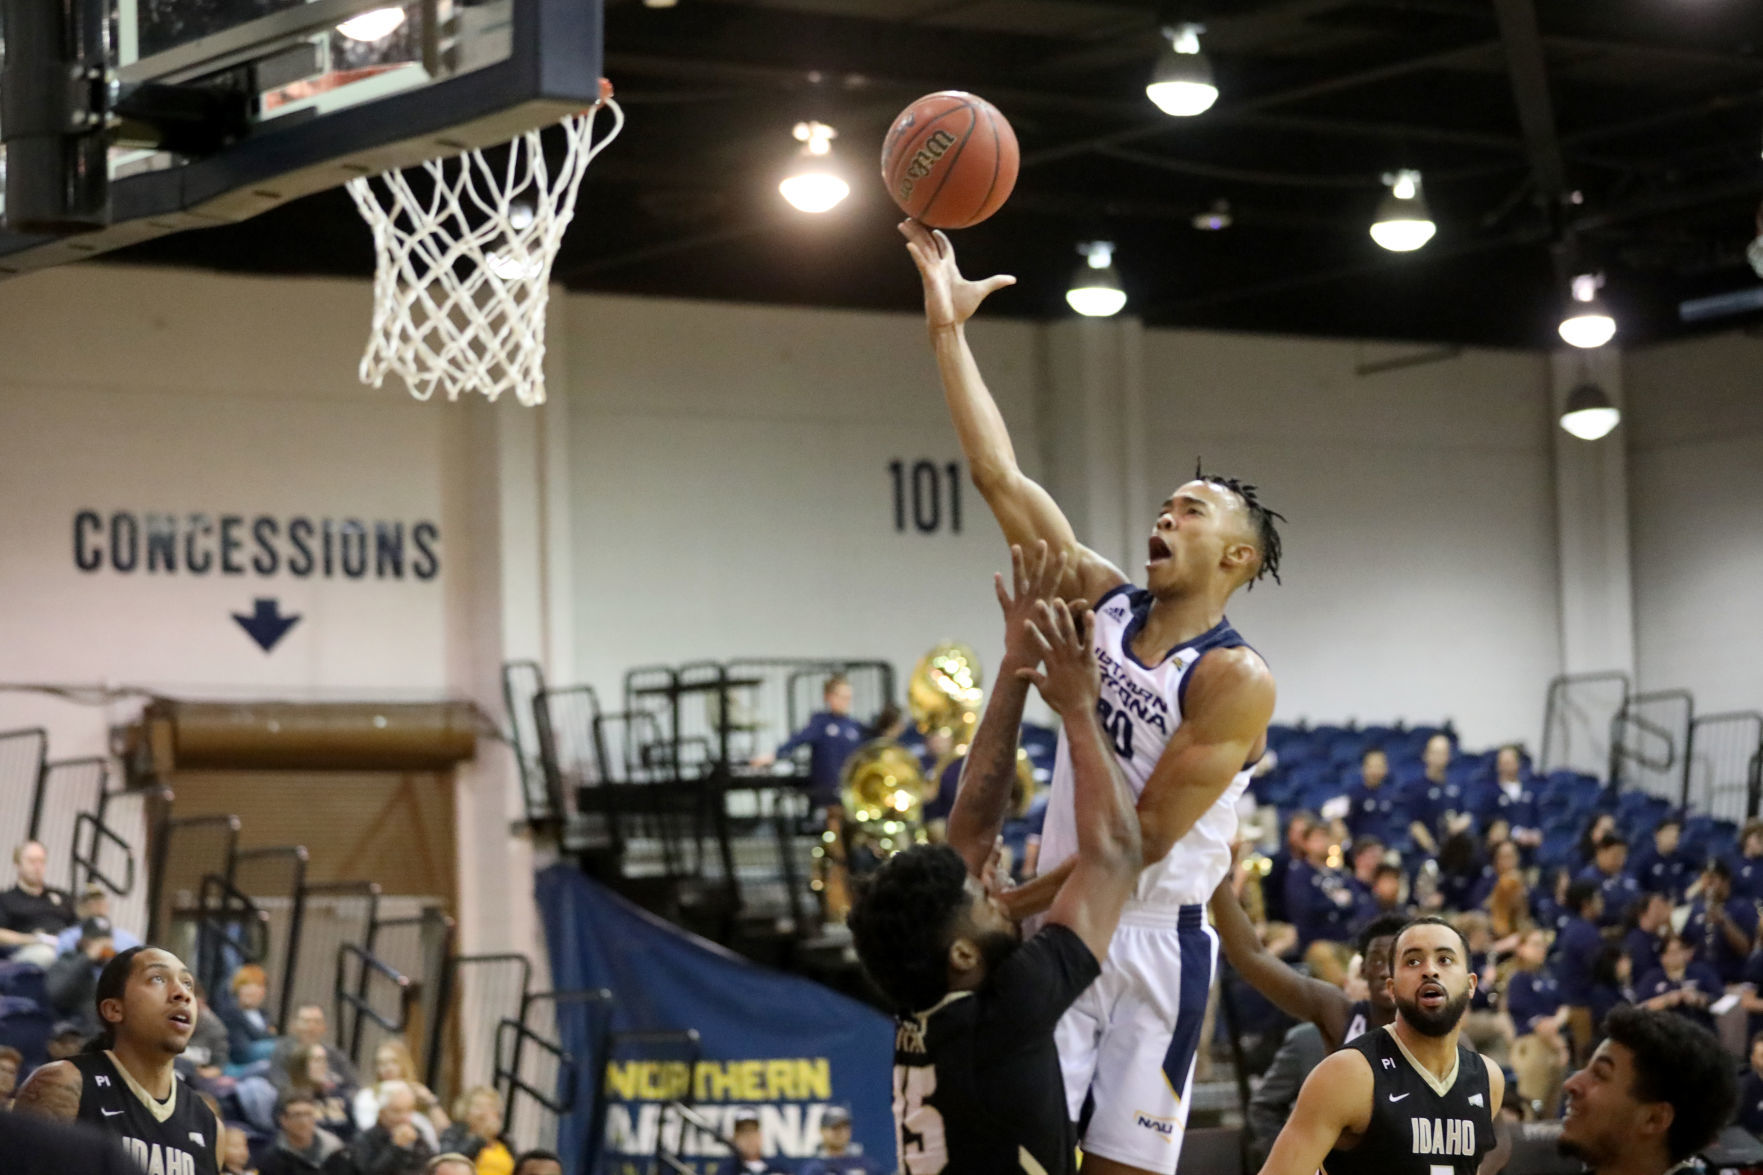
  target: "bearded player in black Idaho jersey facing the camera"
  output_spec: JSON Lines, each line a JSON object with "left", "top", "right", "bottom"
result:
{"left": 1261, "top": 916, "right": 1506, "bottom": 1175}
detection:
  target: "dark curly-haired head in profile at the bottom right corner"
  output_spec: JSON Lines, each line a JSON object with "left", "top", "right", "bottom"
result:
{"left": 1555, "top": 1006, "right": 1737, "bottom": 1175}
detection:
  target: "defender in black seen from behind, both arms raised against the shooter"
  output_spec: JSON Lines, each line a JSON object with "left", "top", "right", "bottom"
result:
{"left": 848, "top": 543, "right": 1142, "bottom": 1175}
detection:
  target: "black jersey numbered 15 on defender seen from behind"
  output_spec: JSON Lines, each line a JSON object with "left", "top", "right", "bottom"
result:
{"left": 894, "top": 924, "right": 1102, "bottom": 1175}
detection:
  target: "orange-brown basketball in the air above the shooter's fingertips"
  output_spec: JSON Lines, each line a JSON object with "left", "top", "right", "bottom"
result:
{"left": 882, "top": 90, "right": 1021, "bottom": 229}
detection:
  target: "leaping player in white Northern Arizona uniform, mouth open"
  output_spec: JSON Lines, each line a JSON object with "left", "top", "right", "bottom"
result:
{"left": 901, "top": 221, "right": 1283, "bottom": 1175}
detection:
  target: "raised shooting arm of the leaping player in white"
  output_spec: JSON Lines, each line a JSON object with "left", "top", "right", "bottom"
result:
{"left": 899, "top": 221, "right": 1127, "bottom": 600}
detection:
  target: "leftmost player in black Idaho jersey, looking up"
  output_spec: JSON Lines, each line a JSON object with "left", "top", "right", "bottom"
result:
{"left": 14, "top": 946, "right": 224, "bottom": 1175}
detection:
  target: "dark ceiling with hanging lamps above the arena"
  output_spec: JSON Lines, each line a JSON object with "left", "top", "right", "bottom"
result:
{"left": 120, "top": 0, "right": 1763, "bottom": 346}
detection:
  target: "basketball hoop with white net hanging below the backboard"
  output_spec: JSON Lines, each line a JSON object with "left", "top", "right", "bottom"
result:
{"left": 349, "top": 79, "right": 624, "bottom": 406}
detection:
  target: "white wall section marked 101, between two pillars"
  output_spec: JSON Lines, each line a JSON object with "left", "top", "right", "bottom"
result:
{"left": 554, "top": 296, "right": 1038, "bottom": 726}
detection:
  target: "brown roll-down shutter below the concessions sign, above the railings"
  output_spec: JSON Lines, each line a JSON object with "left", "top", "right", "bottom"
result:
{"left": 167, "top": 771, "right": 457, "bottom": 899}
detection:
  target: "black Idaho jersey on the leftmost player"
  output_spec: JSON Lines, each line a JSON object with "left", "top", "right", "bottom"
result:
{"left": 71, "top": 1052, "right": 220, "bottom": 1175}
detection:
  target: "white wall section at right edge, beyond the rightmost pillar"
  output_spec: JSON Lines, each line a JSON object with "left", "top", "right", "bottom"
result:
{"left": 1624, "top": 333, "right": 1763, "bottom": 713}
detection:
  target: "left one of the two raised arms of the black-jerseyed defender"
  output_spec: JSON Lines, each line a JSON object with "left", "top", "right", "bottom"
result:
{"left": 948, "top": 543, "right": 1067, "bottom": 877}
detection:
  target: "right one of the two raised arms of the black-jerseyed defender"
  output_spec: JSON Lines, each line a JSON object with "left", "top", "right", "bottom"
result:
{"left": 1019, "top": 600, "right": 1144, "bottom": 958}
